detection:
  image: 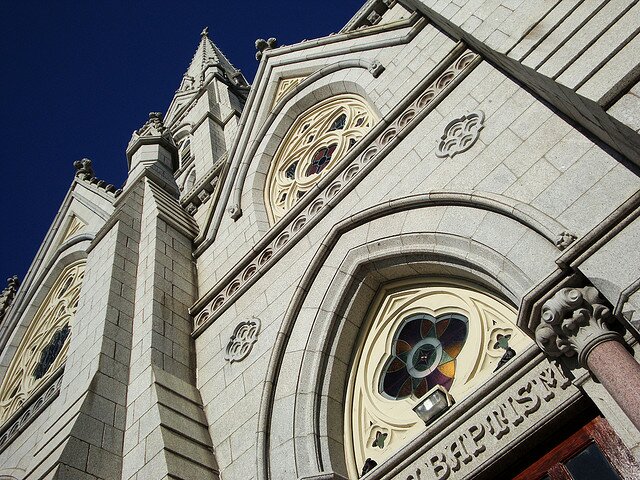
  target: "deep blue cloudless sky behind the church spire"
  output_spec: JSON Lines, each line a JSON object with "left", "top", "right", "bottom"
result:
{"left": 0, "top": 0, "right": 364, "bottom": 284}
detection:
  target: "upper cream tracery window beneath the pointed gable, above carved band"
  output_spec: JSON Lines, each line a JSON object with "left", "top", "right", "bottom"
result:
{"left": 264, "top": 94, "right": 378, "bottom": 224}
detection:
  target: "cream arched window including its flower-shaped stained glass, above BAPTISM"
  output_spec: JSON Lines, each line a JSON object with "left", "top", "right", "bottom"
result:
{"left": 344, "top": 280, "right": 532, "bottom": 478}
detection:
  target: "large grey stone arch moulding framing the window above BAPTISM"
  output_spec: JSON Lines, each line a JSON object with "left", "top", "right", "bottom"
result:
{"left": 258, "top": 193, "right": 561, "bottom": 479}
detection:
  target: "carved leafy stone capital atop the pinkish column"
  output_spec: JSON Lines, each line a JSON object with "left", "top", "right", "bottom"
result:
{"left": 535, "top": 287, "right": 621, "bottom": 367}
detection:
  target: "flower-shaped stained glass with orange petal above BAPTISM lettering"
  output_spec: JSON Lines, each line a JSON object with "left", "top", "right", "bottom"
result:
{"left": 379, "top": 313, "right": 469, "bottom": 400}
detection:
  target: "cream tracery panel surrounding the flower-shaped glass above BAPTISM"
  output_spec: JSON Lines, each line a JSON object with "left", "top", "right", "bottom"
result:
{"left": 344, "top": 281, "right": 532, "bottom": 479}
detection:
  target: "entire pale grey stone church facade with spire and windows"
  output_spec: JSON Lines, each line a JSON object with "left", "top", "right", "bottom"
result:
{"left": 0, "top": 0, "right": 640, "bottom": 480}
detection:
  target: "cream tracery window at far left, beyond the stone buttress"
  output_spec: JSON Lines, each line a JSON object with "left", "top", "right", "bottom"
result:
{"left": 0, "top": 260, "right": 86, "bottom": 425}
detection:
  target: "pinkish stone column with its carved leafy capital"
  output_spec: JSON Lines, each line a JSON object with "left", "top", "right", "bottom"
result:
{"left": 535, "top": 287, "right": 640, "bottom": 430}
